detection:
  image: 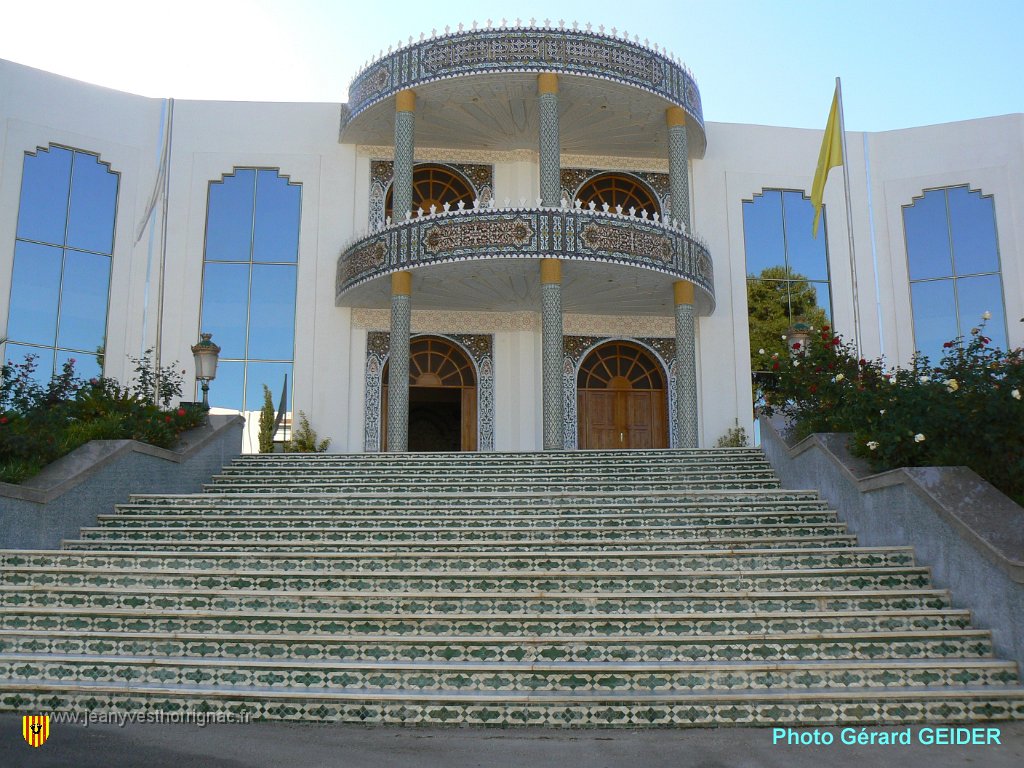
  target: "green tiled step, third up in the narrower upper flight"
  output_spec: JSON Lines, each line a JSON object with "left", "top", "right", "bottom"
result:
{"left": 98, "top": 507, "right": 837, "bottom": 530}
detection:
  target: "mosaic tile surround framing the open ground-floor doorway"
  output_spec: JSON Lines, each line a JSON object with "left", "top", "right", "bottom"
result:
{"left": 362, "top": 333, "right": 495, "bottom": 453}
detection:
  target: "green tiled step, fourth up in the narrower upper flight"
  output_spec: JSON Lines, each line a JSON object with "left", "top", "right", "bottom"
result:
{"left": 118, "top": 488, "right": 826, "bottom": 514}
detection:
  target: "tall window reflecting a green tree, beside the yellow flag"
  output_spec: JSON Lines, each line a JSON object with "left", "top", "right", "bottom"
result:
{"left": 743, "top": 189, "right": 842, "bottom": 371}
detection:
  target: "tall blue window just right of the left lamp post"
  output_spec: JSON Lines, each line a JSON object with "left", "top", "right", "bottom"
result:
{"left": 200, "top": 168, "right": 301, "bottom": 411}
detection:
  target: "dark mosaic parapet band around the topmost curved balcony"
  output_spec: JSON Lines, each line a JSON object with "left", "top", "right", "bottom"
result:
{"left": 341, "top": 24, "right": 703, "bottom": 134}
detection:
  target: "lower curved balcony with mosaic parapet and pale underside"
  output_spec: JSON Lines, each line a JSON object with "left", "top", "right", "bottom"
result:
{"left": 335, "top": 204, "right": 715, "bottom": 315}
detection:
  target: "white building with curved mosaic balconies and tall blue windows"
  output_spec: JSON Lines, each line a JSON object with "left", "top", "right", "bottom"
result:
{"left": 0, "top": 30, "right": 1024, "bottom": 452}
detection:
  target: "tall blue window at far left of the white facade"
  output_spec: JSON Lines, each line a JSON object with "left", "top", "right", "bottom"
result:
{"left": 4, "top": 144, "right": 120, "bottom": 381}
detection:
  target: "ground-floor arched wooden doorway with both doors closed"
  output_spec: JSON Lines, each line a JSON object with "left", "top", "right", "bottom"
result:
{"left": 577, "top": 341, "right": 669, "bottom": 450}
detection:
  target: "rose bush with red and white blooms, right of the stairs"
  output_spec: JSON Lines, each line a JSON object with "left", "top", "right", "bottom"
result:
{"left": 759, "top": 321, "right": 1024, "bottom": 503}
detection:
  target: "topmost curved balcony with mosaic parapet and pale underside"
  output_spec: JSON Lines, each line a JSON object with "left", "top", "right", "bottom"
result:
{"left": 340, "top": 25, "right": 707, "bottom": 158}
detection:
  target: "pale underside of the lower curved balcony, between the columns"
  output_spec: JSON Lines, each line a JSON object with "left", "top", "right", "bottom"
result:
{"left": 338, "top": 259, "right": 699, "bottom": 316}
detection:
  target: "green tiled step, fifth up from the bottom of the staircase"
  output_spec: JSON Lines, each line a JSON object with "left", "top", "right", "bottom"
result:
{"left": 0, "top": 586, "right": 950, "bottom": 617}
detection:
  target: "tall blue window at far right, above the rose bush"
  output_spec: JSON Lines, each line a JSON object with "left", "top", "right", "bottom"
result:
{"left": 903, "top": 184, "right": 1007, "bottom": 360}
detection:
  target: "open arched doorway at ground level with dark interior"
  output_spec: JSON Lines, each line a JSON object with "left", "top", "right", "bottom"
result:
{"left": 381, "top": 336, "right": 476, "bottom": 451}
